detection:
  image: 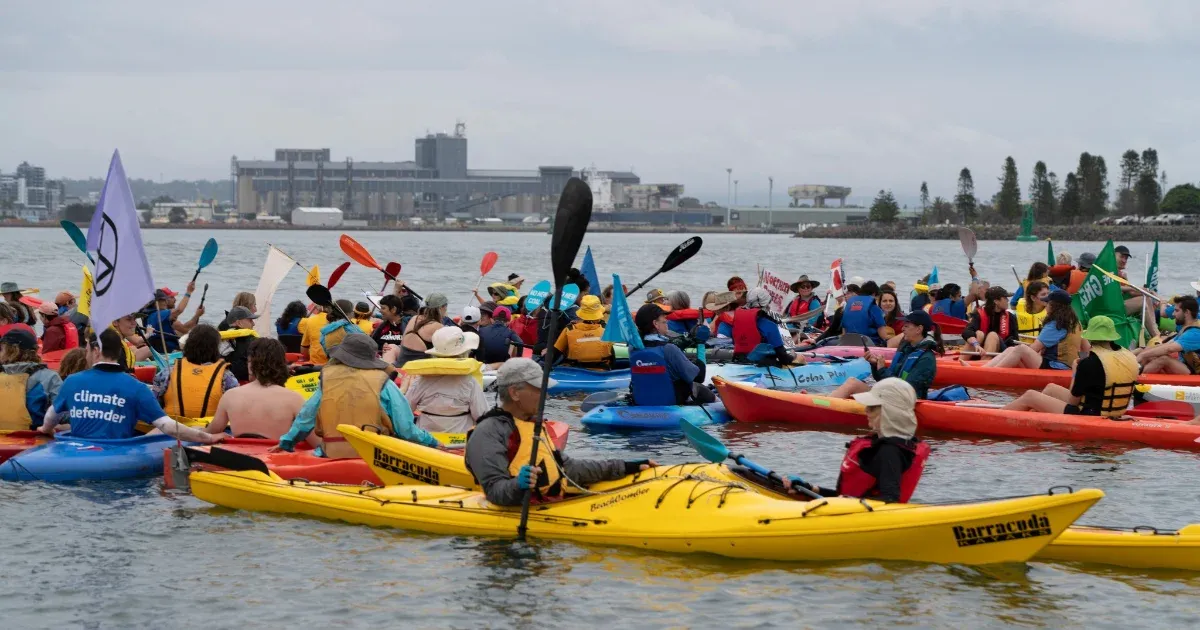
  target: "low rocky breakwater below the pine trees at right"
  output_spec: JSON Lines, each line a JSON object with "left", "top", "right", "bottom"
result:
{"left": 797, "top": 224, "right": 1200, "bottom": 242}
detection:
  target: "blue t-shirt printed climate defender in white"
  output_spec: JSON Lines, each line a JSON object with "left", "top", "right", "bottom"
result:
{"left": 54, "top": 364, "right": 167, "bottom": 439}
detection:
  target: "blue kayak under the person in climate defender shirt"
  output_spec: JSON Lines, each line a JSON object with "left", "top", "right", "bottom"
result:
{"left": 0, "top": 433, "right": 182, "bottom": 481}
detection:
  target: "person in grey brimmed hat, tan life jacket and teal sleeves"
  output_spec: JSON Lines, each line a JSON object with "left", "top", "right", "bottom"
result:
{"left": 270, "top": 335, "right": 440, "bottom": 458}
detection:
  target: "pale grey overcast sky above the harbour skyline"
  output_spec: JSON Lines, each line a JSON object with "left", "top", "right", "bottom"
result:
{"left": 0, "top": 0, "right": 1200, "bottom": 204}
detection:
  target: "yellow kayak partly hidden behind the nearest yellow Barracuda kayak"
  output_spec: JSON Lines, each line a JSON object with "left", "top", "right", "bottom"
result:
{"left": 336, "top": 430, "right": 1200, "bottom": 570}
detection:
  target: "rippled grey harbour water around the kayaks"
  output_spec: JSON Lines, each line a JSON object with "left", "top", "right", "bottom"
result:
{"left": 0, "top": 228, "right": 1200, "bottom": 628}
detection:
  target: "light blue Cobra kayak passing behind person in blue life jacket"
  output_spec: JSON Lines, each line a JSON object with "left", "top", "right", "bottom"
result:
{"left": 550, "top": 359, "right": 871, "bottom": 396}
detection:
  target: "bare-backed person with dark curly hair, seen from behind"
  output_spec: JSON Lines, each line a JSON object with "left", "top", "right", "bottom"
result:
{"left": 204, "top": 332, "right": 304, "bottom": 436}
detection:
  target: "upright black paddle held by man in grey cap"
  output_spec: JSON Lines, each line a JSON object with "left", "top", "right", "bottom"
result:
{"left": 517, "top": 178, "right": 590, "bottom": 541}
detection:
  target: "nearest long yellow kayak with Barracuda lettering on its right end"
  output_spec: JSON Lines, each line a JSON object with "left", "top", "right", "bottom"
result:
{"left": 191, "top": 464, "right": 1104, "bottom": 564}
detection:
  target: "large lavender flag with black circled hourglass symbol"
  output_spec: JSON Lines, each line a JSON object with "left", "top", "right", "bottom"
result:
{"left": 88, "top": 151, "right": 154, "bottom": 335}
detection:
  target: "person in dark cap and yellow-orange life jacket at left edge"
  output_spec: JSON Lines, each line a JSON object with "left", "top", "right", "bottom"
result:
{"left": 0, "top": 329, "right": 62, "bottom": 431}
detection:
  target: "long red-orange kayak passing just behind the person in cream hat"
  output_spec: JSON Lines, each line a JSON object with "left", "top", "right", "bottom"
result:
{"left": 716, "top": 380, "right": 1200, "bottom": 450}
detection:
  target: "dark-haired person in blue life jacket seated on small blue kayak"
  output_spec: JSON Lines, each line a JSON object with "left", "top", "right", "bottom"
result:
{"left": 629, "top": 304, "right": 716, "bottom": 407}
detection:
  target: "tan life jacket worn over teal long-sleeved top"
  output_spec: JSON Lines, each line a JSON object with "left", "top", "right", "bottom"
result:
{"left": 316, "top": 364, "right": 395, "bottom": 458}
